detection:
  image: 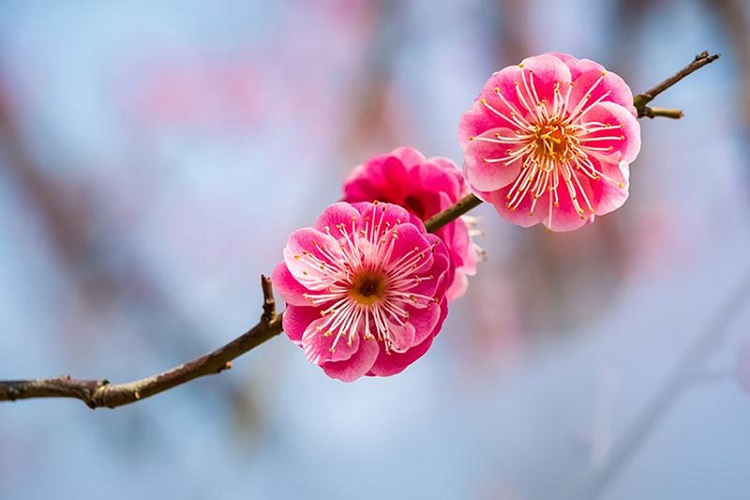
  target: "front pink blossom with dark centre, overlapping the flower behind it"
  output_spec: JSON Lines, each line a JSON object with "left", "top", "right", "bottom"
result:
{"left": 272, "top": 202, "right": 453, "bottom": 382}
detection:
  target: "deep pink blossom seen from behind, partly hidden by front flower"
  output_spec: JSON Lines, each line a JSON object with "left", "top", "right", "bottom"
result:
{"left": 343, "top": 147, "right": 477, "bottom": 301}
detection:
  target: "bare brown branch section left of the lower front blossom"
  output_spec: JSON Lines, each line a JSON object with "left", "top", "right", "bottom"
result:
{"left": 0, "top": 276, "right": 283, "bottom": 409}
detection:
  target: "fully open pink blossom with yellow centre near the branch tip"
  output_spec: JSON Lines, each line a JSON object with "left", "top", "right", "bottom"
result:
{"left": 459, "top": 53, "right": 641, "bottom": 231}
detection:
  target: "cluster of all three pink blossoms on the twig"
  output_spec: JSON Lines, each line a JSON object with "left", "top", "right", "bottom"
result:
{"left": 273, "top": 53, "right": 640, "bottom": 381}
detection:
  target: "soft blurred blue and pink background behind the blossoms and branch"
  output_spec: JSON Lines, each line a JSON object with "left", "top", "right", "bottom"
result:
{"left": 0, "top": 0, "right": 750, "bottom": 500}
